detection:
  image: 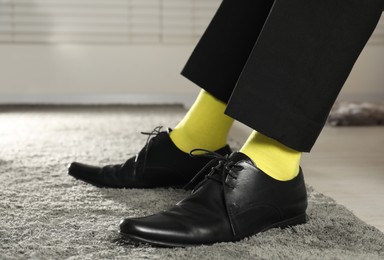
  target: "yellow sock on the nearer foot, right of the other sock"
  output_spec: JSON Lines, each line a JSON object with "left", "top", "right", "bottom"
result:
{"left": 240, "top": 131, "right": 301, "bottom": 181}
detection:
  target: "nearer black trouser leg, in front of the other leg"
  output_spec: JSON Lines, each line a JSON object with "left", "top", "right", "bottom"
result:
{"left": 226, "top": 0, "right": 384, "bottom": 152}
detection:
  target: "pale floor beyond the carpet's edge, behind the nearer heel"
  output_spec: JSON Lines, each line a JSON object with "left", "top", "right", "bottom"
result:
{"left": 231, "top": 124, "right": 384, "bottom": 232}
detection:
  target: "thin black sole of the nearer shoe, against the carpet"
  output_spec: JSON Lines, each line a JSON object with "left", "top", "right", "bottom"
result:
{"left": 119, "top": 213, "right": 308, "bottom": 248}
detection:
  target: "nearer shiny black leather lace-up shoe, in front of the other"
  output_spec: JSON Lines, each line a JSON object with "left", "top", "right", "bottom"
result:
{"left": 120, "top": 153, "right": 307, "bottom": 247}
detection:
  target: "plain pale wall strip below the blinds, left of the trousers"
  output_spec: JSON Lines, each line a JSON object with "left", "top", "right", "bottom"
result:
{"left": 0, "top": 45, "right": 201, "bottom": 103}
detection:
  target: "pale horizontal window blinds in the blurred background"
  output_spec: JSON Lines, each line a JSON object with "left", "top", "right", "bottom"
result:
{"left": 0, "top": 0, "right": 221, "bottom": 44}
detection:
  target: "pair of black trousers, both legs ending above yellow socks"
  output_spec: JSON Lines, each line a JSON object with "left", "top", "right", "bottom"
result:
{"left": 182, "top": 0, "right": 384, "bottom": 152}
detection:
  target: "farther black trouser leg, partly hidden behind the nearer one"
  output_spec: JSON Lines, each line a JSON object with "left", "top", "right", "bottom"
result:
{"left": 181, "top": 0, "right": 273, "bottom": 103}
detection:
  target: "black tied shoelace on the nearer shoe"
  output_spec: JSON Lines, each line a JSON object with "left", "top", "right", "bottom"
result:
{"left": 184, "top": 148, "right": 243, "bottom": 192}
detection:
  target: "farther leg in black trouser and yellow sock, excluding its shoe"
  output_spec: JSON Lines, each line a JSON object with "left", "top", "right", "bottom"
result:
{"left": 171, "top": 0, "right": 273, "bottom": 152}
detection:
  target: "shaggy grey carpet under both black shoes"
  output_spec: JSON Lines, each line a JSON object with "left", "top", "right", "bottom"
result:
{"left": 0, "top": 106, "right": 384, "bottom": 259}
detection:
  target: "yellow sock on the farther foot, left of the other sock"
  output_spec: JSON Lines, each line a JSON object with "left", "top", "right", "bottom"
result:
{"left": 170, "top": 90, "right": 234, "bottom": 153}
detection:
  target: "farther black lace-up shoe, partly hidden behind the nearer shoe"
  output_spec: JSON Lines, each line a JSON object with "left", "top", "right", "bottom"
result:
{"left": 68, "top": 127, "right": 231, "bottom": 188}
